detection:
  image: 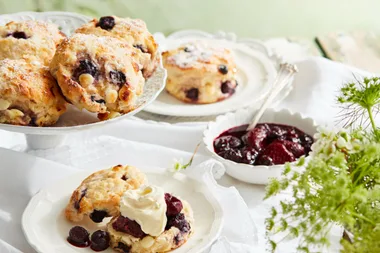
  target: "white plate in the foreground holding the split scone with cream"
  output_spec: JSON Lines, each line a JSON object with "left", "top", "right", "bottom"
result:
{"left": 22, "top": 168, "right": 223, "bottom": 253}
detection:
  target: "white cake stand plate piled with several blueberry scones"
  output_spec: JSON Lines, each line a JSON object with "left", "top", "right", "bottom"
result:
{"left": 0, "top": 12, "right": 166, "bottom": 135}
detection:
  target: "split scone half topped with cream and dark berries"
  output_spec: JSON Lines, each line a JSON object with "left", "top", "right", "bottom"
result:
{"left": 107, "top": 186, "right": 194, "bottom": 253}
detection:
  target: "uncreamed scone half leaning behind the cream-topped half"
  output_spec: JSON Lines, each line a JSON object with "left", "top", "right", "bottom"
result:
{"left": 65, "top": 165, "right": 147, "bottom": 223}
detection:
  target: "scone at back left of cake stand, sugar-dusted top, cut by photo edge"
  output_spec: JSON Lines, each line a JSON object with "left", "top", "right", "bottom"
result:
{"left": 0, "top": 20, "right": 65, "bottom": 65}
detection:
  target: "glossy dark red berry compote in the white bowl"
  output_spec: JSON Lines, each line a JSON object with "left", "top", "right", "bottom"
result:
{"left": 214, "top": 123, "right": 314, "bottom": 165}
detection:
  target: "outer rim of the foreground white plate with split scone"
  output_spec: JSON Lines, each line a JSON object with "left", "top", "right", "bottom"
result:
{"left": 21, "top": 167, "right": 225, "bottom": 253}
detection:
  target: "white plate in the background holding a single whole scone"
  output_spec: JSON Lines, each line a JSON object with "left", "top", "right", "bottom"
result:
{"left": 144, "top": 30, "right": 277, "bottom": 117}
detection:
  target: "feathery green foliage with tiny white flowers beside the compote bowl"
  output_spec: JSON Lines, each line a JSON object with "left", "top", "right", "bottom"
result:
{"left": 265, "top": 78, "right": 380, "bottom": 253}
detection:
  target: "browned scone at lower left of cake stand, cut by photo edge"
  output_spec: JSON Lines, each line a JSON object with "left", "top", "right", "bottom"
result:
{"left": 0, "top": 59, "right": 66, "bottom": 126}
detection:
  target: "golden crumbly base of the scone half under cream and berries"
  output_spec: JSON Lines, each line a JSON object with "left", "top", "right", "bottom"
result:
{"left": 107, "top": 200, "right": 194, "bottom": 253}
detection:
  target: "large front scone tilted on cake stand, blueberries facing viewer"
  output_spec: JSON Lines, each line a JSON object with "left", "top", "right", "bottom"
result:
{"left": 50, "top": 34, "right": 145, "bottom": 114}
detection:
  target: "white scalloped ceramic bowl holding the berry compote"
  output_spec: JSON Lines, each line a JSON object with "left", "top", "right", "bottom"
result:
{"left": 203, "top": 109, "right": 317, "bottom": 184}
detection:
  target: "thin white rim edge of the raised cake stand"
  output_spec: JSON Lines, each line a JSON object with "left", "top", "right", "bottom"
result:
{"left": 0, "top": 11, "right": 167, "bottom": 135}
